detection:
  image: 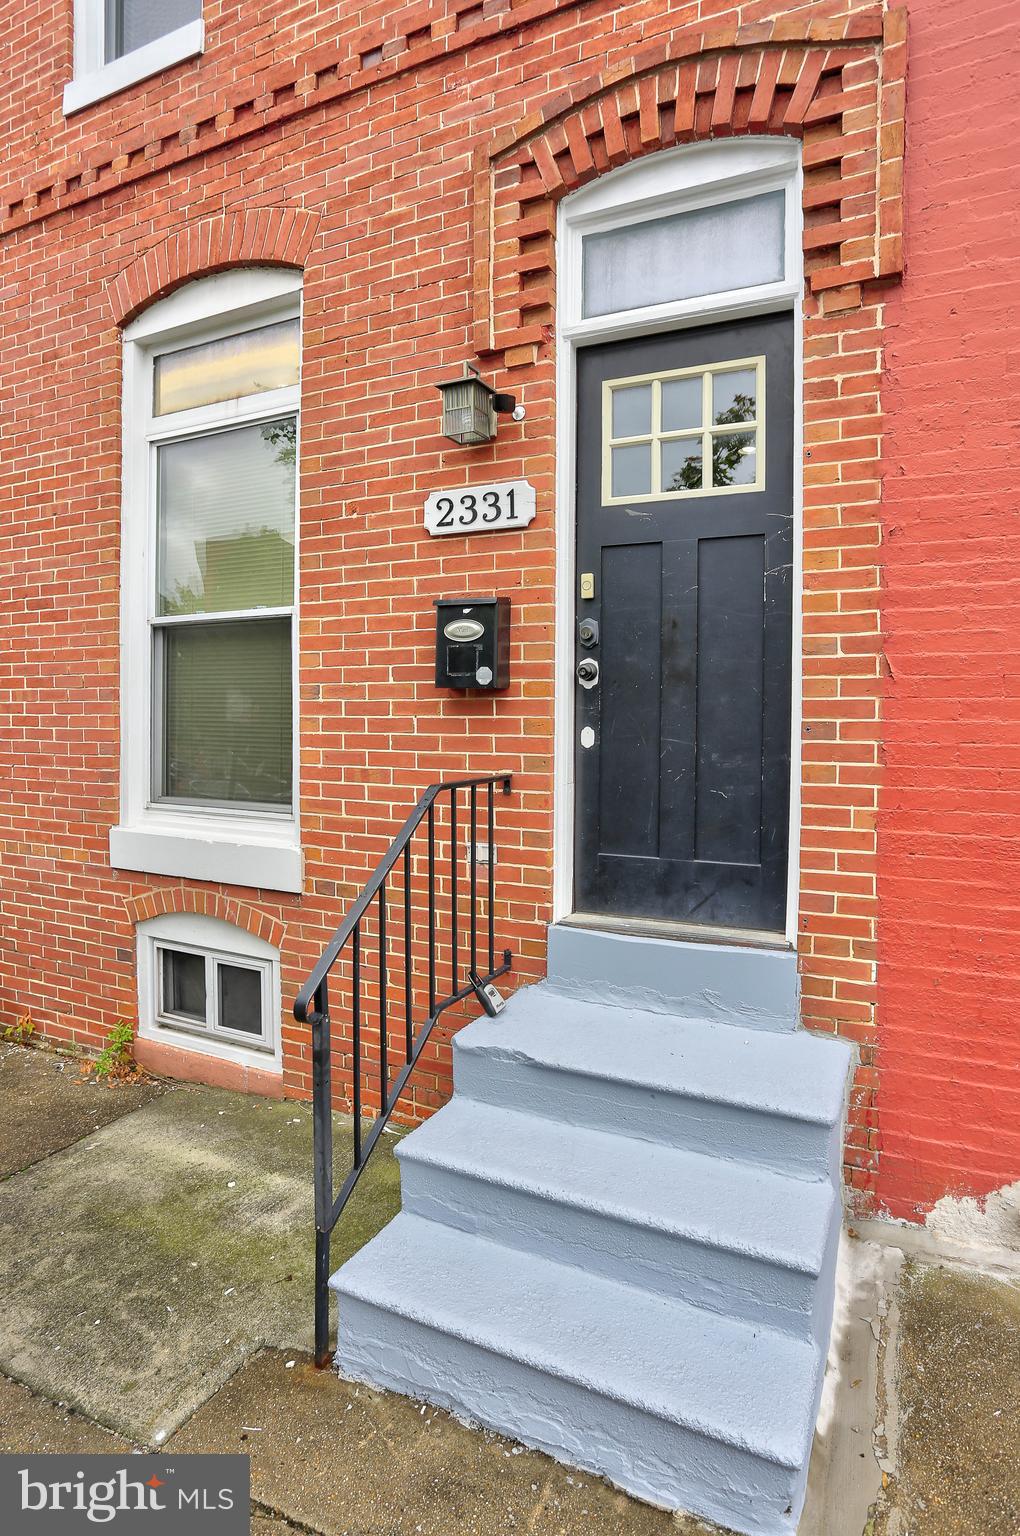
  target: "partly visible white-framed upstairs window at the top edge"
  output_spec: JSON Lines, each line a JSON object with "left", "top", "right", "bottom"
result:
{"left": 63, "top": 0, "right": 204, "bottom": 115}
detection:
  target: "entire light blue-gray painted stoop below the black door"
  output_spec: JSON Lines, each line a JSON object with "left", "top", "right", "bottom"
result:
{"left": 332, "top": 929, "right": 851, "bottom": 1533}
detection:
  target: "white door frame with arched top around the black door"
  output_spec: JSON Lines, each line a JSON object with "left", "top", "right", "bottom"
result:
{"left": 553, "top": 137, "right": 803, "bottom": 948}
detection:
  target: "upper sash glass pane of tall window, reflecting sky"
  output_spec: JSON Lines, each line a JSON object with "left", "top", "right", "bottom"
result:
{"left": 158, "top": 416, "right": 296, "bottom": 614}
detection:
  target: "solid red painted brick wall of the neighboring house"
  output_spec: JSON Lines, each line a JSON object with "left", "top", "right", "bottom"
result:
{"left": 876, "top": 0, "right": 1020, "bottom": 1217}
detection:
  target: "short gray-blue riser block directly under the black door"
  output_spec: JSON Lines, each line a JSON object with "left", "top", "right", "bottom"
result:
{"left": 548, "top": 923, "right": 797, "bottom": 1031}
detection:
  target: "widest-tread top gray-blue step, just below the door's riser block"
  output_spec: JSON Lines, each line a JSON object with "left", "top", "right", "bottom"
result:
{"left": 453, "top": 983, "right": 851, "bottom": 1180}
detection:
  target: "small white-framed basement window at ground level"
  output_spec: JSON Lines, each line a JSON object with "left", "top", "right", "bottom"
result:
{"left": 137, "top": 912, "right": 280, "bottom": 1071}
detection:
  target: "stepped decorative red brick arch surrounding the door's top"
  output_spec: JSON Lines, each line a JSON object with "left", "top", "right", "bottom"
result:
{"left": 475, "top": 6, "right": 906, "bottom": 367}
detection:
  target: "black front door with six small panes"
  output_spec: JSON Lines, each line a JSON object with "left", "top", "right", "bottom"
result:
{"left": 575, "top": 315, "right": 793, "bottom": 931}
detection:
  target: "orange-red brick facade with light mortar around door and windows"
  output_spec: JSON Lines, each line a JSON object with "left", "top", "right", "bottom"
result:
{"left": 0, "top": 0, "right": 903, "bottom": 1187}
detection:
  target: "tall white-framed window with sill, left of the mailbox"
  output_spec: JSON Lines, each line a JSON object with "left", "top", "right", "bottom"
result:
{"left": 111, "top": 269, "right": 301, "bottom": 891}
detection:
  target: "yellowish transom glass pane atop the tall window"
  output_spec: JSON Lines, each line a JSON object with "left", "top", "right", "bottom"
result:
{"left": 152, "top": 319, "right": 301, "bottom": 416}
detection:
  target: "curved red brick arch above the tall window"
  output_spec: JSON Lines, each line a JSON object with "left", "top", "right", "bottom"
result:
{"left": 106, "top": 204, "right": 320, "bottom": 326}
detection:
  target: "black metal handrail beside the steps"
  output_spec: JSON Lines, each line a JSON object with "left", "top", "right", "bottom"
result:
{"left": 293, "top": 773, "right": 513, "bottom": 1366}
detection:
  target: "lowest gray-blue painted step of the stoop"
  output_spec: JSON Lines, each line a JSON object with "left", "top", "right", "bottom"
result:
{"left": 333, "top": 1213, "right": 820, "bottom": 1533}
